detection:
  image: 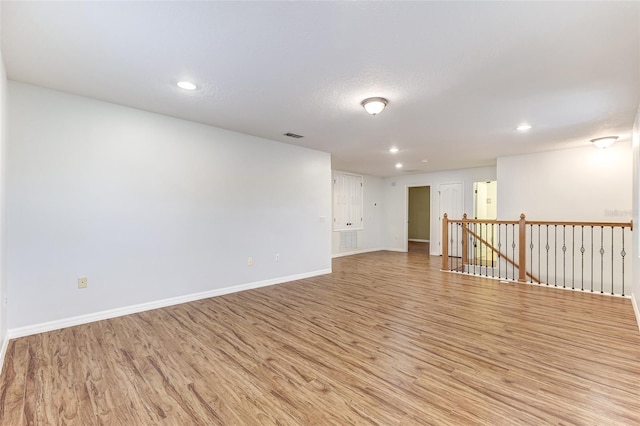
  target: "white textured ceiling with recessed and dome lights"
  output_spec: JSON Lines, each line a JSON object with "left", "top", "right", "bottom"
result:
{"left": 1, "top": 1, "right": 640, "bottom": 176}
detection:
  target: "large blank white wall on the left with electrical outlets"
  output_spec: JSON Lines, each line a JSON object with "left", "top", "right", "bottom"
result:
{"left": 6, "top": 82, "right": 331, "bottom": 329}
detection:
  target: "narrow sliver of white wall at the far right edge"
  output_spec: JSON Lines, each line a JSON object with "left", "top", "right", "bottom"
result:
{"left": 631, "top": 107, "right": 640, "bottom": 326}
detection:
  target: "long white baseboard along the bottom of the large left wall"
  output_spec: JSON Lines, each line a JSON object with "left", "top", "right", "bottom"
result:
{"left": 7, "top": 269, "right": 331, "bottom": 340}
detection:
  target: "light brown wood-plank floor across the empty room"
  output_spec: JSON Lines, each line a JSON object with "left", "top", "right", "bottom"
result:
{"left": 0, "top": 245, "right": 640, "bottom": 426}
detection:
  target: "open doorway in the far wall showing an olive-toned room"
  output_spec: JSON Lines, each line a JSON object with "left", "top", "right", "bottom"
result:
{"left": 407, "top": 186, "right": 431, "bottom": 255}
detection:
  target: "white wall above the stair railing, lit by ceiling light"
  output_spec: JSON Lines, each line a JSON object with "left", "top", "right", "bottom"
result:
{"left": 498, "top": 145, "right": 632, "bottom": 222}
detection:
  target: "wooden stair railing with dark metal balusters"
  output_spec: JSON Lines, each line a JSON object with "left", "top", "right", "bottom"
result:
{"left": 442, "top": 214, "right": 633, "bottom": 296}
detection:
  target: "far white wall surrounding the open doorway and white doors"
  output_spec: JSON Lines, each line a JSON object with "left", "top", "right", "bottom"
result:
{"left": 382, "top": 167, "right": 500, "bottom": 255}
